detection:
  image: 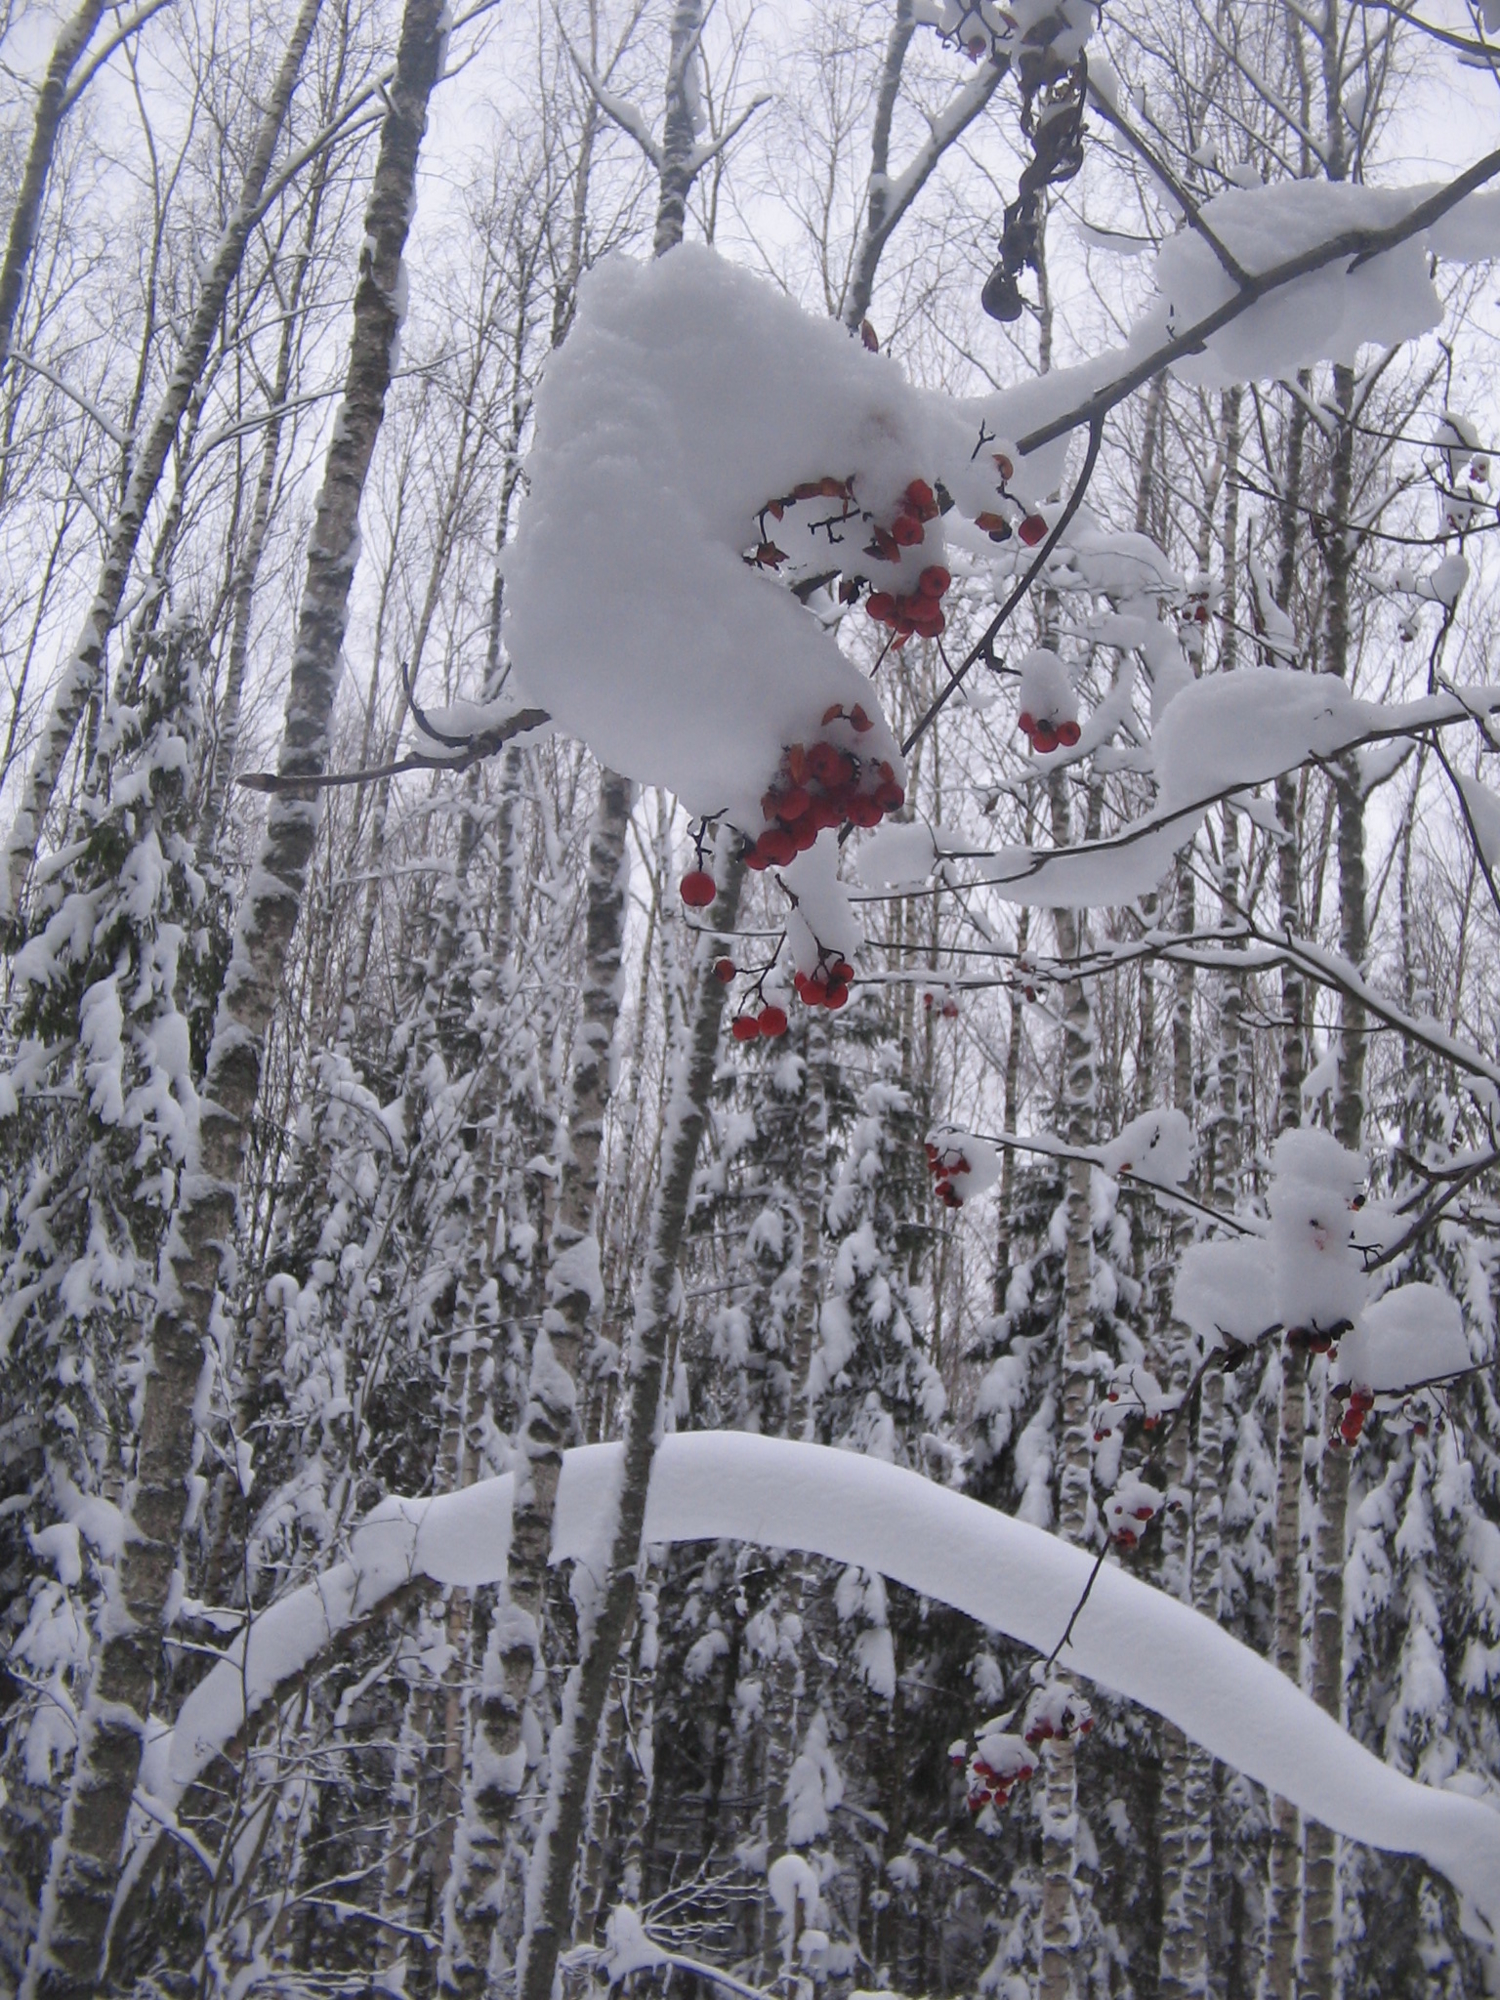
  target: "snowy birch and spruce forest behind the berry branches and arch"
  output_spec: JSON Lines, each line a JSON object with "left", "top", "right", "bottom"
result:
{"left": 0, "top": 0, "right": 1500, "bottom": 2000}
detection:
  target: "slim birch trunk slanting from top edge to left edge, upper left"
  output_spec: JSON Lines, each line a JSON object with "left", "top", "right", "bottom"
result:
{"left": 0, "top": 0, "right": 322, "bottom": 924}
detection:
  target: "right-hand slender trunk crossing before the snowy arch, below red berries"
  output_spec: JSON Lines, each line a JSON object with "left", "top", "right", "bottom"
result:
{"left": 516, "top": 834, "right": 744, "bottom": 2000}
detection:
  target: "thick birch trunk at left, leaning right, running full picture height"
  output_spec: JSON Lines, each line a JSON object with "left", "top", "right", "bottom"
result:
{"left": 26, "top": 11, "right": 444, "bottom": 2000}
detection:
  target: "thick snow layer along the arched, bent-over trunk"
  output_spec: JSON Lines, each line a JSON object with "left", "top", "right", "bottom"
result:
{"left": 156, "top": 1432, "right": 1500, "bottom": 1924}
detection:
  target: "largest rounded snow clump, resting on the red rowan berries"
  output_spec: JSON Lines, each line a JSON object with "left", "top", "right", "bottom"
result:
{"left": 506, "top": 244, "right": 956, "bottom": 832}
